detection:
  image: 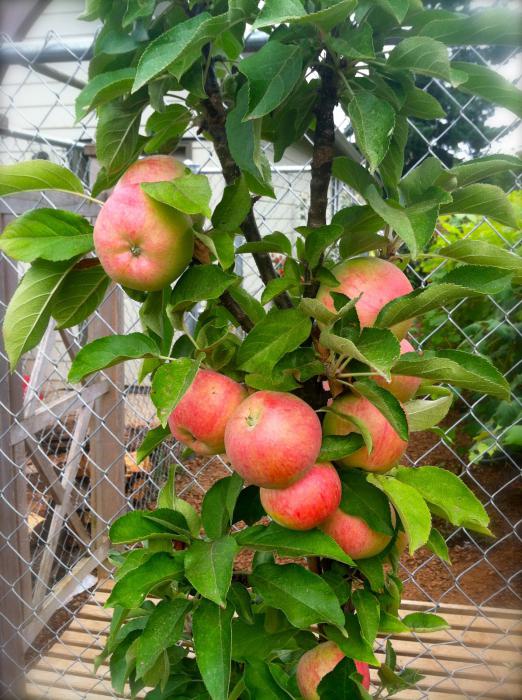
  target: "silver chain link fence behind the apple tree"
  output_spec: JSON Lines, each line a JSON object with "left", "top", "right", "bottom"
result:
{"left": 0, "top": 23, "right": 522, "bottom": 699}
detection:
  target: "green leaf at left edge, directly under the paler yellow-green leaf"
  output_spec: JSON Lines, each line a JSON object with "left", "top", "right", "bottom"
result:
{"left": 0, "top": 209, "right": 93, "bottom": 262}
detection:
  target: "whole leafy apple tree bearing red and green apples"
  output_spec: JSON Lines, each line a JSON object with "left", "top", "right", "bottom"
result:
{"left": 0, "top": 0, "right": 522, "bottom": 700}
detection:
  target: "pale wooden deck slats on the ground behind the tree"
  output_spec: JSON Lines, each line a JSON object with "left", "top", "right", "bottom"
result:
{"left": 27, "top": 580, "right": 522, "bottom": 700}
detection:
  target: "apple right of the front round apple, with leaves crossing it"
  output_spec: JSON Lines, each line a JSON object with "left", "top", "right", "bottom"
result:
{"left": 323, "top": 393, "right": 408, "bottom": 472}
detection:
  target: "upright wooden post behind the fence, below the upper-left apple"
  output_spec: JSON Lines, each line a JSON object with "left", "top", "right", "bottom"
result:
{"left": 89, "top": 285, "right": 127, "bottom": 547}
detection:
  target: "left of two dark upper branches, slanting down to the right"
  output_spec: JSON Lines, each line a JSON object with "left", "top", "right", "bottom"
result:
{"left": 201, "top": 58, "right": 292, "bottom": 309}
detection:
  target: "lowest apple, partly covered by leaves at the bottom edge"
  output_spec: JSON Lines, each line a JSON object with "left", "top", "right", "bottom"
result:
{"left": 296, "top": 642, "right": 370, "bottom": 700}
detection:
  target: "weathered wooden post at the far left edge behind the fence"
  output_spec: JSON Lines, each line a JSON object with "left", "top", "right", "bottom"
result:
{"left": 0, "top": 258, "right": 31, "bottom": 698}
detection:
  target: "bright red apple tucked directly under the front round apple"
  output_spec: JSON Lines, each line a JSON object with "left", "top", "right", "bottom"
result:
{"left": 259, "top": 462, "right": 341, "bottom": 530}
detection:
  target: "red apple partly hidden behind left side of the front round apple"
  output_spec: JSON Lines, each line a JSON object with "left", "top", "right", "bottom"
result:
{"left": 168, "top": 369, "right": 247, "bottom": 455}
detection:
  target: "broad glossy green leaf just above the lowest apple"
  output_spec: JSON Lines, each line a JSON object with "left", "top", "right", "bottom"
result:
{"left": 249, "top": 560, "right": 344, "bottom": 629}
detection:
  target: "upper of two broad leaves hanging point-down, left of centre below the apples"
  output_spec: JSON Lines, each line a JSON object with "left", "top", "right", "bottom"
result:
{"left": 185, "top": 535, "right": 237, "bottom": 608}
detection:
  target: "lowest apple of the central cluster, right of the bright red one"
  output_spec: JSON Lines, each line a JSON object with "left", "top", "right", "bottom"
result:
{"left": 320, "top": 508, "right": 391, "bottom": 559}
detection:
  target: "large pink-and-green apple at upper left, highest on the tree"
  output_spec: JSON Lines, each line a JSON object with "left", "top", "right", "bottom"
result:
{"left": 94, "top": 182, "right": 194, "bottom": 292}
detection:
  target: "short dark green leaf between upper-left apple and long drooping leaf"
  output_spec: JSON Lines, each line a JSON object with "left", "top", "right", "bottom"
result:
{"left": 52, "top": 259, "right": 110, "bottom": 330}
